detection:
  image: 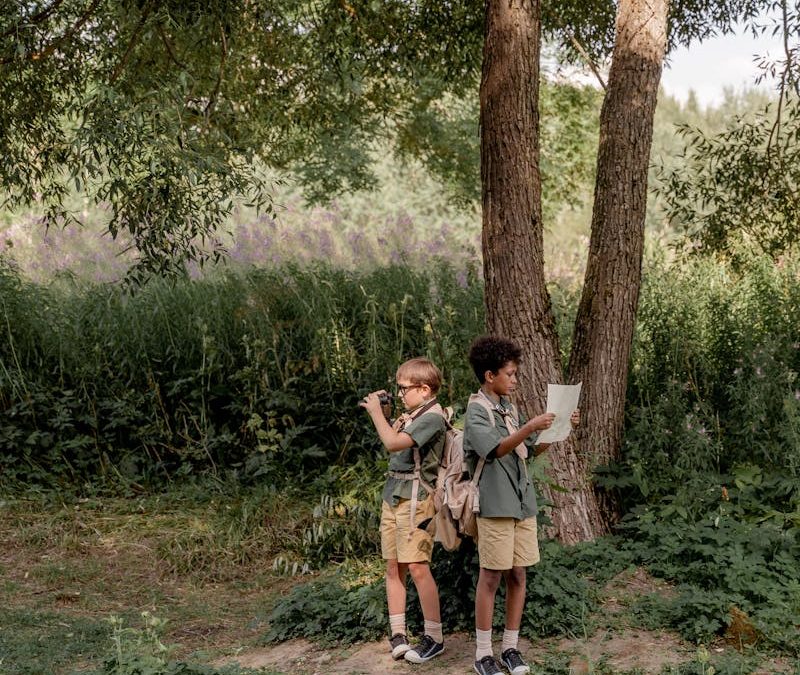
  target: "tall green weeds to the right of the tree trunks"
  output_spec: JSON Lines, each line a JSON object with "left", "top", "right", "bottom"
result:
{"left": 623, "top": 248, "right": 800, "bottom": 483}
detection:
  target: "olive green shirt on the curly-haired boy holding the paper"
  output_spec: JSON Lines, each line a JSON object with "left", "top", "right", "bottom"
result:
{"left": 464, "top": 398, "right": 538, "bottom": 520}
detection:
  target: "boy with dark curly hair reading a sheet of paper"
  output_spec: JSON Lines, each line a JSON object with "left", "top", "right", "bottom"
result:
{"left": 464, "top": 336, "right": 580, "bottom": 675}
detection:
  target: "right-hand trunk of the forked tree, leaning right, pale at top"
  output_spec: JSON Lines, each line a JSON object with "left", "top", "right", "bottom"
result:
{"left": 569, "top": 0, "right": 669, "bottom": 524}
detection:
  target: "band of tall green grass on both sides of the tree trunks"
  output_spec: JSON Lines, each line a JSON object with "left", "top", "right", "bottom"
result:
{"left": 0, "top": 248, "right": 800, "bottom": 496}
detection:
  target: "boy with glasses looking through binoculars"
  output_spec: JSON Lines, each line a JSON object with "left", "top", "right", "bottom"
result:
{"left": 359, "top": 358, "right": 446, "bottom": 663}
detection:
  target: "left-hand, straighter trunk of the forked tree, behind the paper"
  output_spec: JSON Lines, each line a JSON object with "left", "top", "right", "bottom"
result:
{"left": 480, "top": 0, "right": 603, "bottom": 543}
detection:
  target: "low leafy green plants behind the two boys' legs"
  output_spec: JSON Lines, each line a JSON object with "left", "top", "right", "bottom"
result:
{"left": 267, "top": 538, "right": 632, "bottom": 642}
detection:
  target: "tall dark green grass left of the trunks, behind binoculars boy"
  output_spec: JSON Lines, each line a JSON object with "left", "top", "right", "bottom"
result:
{"left": 0, "top": 263, "right": 483, "bottom": 489}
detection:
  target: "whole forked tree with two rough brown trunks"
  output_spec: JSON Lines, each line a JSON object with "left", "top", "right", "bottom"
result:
{"left": 480, "top": 0, "right": 669, "bottom": 543}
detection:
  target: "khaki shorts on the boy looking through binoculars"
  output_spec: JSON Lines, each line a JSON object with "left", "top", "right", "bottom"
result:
{"left": 381, "top": 497, "right": 434, "bottom": 563}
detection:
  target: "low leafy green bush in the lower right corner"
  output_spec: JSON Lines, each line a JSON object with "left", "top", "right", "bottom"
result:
{"left": 621, "top": 467, "right": 800, "bottom": 651}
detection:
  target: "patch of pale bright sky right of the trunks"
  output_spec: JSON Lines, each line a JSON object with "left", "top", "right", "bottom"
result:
{"left": 661, "top": 20, "right": 782, "bottom": 107}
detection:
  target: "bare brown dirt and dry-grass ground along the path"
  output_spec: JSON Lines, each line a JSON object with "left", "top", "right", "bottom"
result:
{"left": 0, "top": 504, "right": 791, "bottom": 675}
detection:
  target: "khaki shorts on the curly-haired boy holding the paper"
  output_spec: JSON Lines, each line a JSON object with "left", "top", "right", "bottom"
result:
{"left": 478, "top": 516, "right": 539, "bottom": 570}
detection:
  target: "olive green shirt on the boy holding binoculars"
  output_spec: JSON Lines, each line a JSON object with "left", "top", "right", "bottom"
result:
{"left": 383, "top": 406, "right": 446, "bottom": 506}
